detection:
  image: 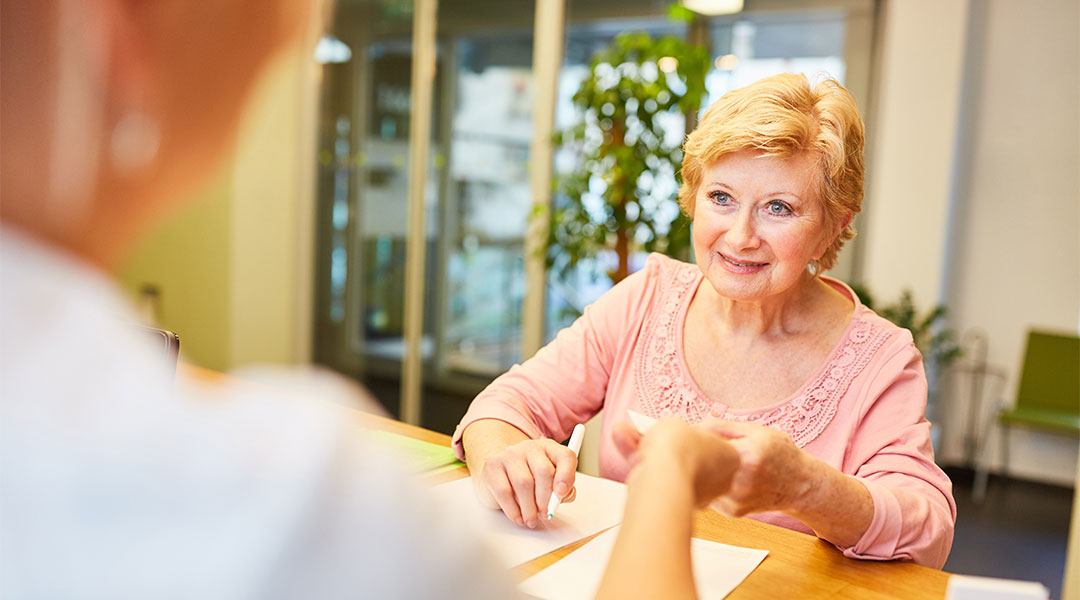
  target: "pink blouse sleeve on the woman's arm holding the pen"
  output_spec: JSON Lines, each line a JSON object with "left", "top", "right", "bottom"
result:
{"left": 453, "top": 256, "right": 662, "bottom": 460}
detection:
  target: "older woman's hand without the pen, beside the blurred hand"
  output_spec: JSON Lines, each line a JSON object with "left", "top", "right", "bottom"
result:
{"left": 700, "top": 421, "right": 813, "bottom": 517}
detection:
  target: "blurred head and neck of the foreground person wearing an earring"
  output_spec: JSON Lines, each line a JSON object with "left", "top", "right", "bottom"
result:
{"left": 0, "top": 0, "right": 321, "bottom": 263}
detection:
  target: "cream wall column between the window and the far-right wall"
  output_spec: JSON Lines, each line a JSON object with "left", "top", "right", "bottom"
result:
{"left": 860, "top": 0, "right": 968, "bottom": 303}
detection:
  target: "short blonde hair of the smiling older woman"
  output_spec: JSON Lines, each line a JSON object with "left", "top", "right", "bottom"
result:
{"left": 678, "top": 73, "right": 863, "bottom": 273}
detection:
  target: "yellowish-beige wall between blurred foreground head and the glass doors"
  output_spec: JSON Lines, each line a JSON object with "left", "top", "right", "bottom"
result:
{"left": 121, "top": 49, "right": 318, "bottom": 370}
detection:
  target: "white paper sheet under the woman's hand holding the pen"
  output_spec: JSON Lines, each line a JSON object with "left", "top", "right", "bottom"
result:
{"left": 433, "top": 473, "right": 626, "bottom": 567}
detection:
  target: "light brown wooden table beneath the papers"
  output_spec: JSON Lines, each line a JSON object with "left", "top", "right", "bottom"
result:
{"left": 363, "top": 415, "right": 949, "bottom": 600}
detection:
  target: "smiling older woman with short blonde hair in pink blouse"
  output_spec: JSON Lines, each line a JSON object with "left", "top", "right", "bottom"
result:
{"left": 454, "top": 74, "right": 956, "bottom": 568}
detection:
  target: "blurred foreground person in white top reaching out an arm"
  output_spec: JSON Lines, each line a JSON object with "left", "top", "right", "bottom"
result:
{"left": 0, "top": 0, "right": 738, "bottom": 599}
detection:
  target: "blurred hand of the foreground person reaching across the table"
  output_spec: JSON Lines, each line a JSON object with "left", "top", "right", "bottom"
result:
{"left": 612, "top": 418, "right": 739, "bottom": 506}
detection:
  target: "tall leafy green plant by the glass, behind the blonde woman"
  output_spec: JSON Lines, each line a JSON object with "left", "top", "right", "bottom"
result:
{"left": 546, "top": 32, "right": 708, "bottom": 283}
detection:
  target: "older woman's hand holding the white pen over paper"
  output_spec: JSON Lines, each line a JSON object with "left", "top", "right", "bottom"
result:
{"left": 462, "top": 420, "right": 578, "bottom": 528}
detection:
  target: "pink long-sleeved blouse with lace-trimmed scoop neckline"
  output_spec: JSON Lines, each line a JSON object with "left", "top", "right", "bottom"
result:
{"left": 454, "top": 255, "right": 956, "bottom": 569}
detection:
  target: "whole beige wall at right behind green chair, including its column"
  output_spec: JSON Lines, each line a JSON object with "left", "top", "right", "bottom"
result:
{"left": 862, "top": 0, "right": 1080, "bottom": 483}
